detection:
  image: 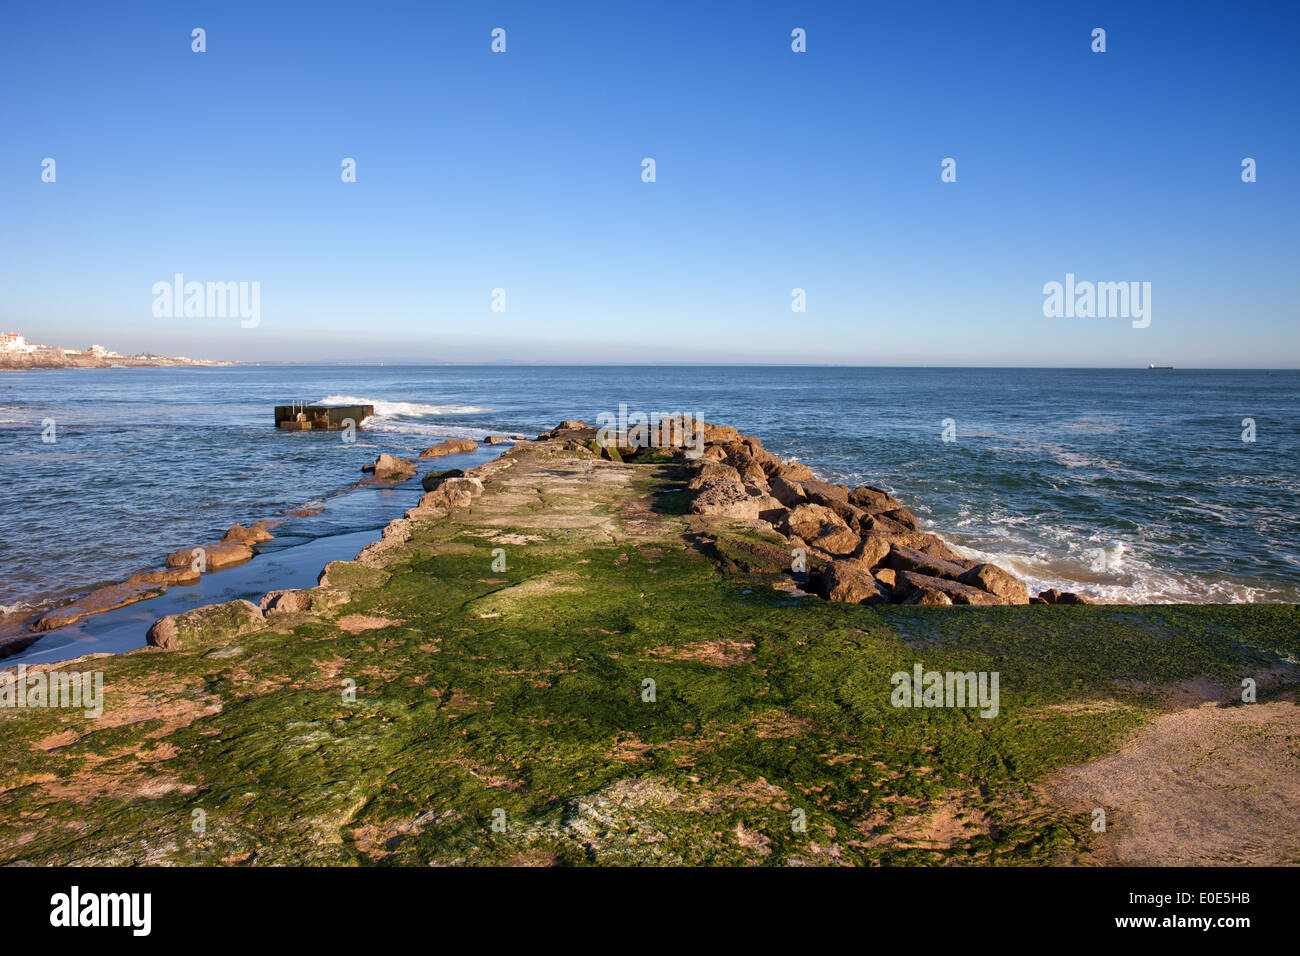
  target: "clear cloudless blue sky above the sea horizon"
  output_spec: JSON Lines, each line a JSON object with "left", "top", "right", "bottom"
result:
{"left": 0, "top": 1, "right": 1300, "bottom": 367}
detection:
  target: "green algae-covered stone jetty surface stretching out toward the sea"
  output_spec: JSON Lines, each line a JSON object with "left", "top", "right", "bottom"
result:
{"left": 0, "top": 447, "right": 1300, "bottom": 865}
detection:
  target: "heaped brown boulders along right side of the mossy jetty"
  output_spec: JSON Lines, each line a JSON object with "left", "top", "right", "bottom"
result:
{"left": 655, "top": 421, "right": 1087, "bottom": 606}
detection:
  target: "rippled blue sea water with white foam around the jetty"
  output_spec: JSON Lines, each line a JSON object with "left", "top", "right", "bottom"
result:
{"left": 0, "top": 365, "right": 1300, "bottom": 655}
